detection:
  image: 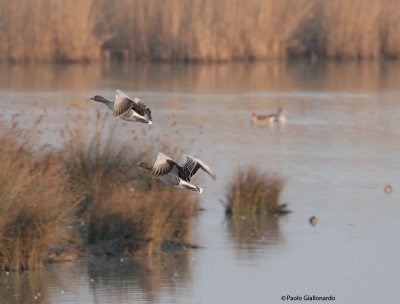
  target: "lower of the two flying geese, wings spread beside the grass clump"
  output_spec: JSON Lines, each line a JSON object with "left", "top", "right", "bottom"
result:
{"left": 137, "top": 152, "right": 216, "bottom": 193}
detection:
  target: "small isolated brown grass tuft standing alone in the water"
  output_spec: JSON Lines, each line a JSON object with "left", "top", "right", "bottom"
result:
{"left": 225, "top": 166, "right": 289, "bottom": 216}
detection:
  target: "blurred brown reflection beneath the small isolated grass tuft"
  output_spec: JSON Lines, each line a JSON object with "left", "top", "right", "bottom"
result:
{"left": 226, "top": 215, "right": 285, "bottom": 259}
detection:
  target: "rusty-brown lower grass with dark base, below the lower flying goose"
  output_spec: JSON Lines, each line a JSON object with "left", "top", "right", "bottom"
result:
{"left": 88, "top": 187, "right": 197, "bottom": 255}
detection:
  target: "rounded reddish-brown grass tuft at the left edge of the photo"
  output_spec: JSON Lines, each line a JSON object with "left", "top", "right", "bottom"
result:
{"left": 0, "top": 120, "right": 74, "bottom": 270}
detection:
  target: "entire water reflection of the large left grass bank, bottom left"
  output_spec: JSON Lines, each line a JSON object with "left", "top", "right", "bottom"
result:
{"left": 0, "top": 251, "right": 191, "bottom": 304}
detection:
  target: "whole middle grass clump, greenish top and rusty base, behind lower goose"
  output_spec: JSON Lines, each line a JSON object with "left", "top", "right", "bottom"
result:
{"left": 63, "top": 115, "right": 197, "bottom": 255}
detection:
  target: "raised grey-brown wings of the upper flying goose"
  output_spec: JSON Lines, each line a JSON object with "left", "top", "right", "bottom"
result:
{"left": 114, "top": 90, "right": 151, "bottom": 120}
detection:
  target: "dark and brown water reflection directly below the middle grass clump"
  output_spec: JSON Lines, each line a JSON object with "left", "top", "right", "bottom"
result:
{"left": 87, "top": 251, "right": 191, "bottom": 303}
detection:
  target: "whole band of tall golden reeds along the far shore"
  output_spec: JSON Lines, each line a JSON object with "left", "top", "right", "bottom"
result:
{"left": 0, "top": 0, "right": 400, "bottom": 62}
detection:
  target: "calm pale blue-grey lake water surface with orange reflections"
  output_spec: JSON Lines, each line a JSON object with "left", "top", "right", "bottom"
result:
{"left": 0, "top": 62, "right": 400, "bottom": 304}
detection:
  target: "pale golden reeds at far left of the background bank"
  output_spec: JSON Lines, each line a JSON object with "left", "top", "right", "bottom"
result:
{"left": 0, "top": 0, "right": 101, "bottom": 62}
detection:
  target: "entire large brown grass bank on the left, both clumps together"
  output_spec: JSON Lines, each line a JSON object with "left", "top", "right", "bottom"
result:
{"left": 0, "top": 115, "right": 198, "bottom": 271}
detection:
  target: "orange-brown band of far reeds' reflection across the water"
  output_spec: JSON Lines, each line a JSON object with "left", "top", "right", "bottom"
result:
{"left": 0, "top": 61, "right": 400, "bottom": 93}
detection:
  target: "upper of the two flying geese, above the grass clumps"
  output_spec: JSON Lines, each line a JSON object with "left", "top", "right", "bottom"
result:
{"left": 90, "top": 90, "right": 153, "bottom": 125}
